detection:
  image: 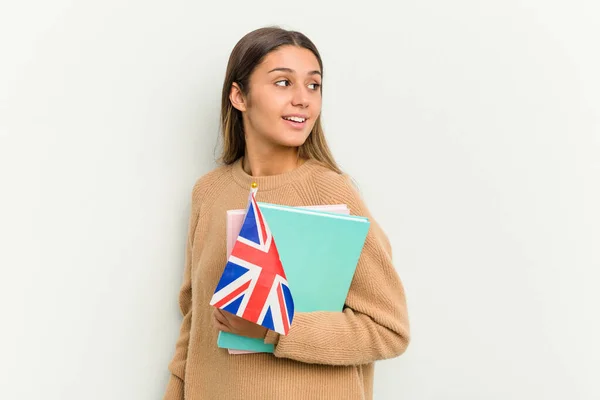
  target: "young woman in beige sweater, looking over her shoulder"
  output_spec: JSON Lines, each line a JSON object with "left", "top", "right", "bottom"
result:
{"left": 164, "top": 27, "right": 409, "bottom": 400}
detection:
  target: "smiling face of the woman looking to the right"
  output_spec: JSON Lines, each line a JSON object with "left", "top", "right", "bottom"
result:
{"left": 232, "top": 46, "right": 321, "bottom": 151}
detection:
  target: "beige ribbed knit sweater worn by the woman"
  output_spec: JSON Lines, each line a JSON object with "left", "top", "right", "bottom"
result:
{"left": 164, "top": 160, "right": 409, "bottom": 400}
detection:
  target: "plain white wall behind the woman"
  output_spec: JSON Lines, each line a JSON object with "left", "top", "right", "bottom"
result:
{"left": 0, "top": 0, "right": 600, "bottom": 400}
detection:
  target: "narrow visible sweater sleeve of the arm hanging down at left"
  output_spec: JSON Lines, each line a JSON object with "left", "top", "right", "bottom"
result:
{"left": 163, "top": 183, "right": 199, "bottom": 400}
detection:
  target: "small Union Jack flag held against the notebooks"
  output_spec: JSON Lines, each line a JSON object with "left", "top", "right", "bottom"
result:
{"left": 210, "top": 190, "right": 294, "bottom": 335}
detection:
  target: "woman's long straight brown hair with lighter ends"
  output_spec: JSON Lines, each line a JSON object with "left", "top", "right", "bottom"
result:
{"left": 219, "top": 27, "right": 342, "bottom": 174}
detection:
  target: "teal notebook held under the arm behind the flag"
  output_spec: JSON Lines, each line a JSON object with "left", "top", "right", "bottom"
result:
{"left": 217, "top": 202, "right": 370, "bottom": 352}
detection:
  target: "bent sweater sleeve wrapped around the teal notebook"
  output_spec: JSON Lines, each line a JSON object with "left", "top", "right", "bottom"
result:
{"left": 264, "top": 173, "right": 410, "bottom": 365}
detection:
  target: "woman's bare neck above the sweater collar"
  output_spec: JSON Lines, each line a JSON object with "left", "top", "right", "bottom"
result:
{"left": 242, "top": 146, "right": 304, "bottom": 176}
